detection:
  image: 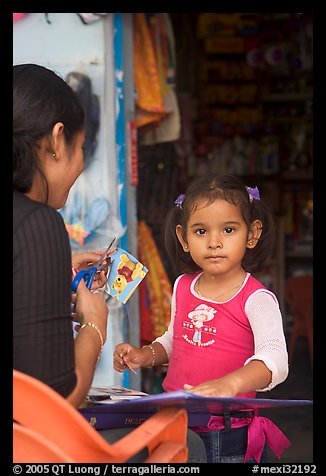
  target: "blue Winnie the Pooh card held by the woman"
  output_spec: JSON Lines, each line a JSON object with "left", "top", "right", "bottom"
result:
{"left": 106, "top": 248, "right": 148, "bottom": 304}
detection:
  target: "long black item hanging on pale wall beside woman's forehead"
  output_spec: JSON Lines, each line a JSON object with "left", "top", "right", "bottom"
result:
{"left": 65, "top": 71, "right": 100, "bottom": 168}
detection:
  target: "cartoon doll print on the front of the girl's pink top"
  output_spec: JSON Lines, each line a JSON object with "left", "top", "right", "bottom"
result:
{"left": 182, "top": 304, "right": 217, "bottom": 347}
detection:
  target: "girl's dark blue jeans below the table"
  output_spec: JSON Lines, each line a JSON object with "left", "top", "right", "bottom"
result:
{"left": 198, "top": 426, "right": 267, "bottom": 463}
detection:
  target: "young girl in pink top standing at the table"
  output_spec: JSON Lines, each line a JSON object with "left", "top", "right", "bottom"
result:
{"left": 114, "top": 175, "right": 289, "bottom": 463}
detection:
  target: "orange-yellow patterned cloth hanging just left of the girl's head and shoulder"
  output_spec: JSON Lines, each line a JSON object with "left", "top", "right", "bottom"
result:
{"left": 138, "top": 221, "right": 172, "bottom": 340}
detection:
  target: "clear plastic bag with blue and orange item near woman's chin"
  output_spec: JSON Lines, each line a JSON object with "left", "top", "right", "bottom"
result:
{"left": 60, "top": 172, "right": 125, "bottom": 249}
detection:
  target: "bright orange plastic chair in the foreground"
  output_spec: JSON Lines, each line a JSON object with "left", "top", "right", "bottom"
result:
{"left": 13, "top": 370, "right": 188, "bottom": 463}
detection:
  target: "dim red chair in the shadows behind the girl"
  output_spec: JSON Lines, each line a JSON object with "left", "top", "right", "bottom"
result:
{"left": 284, "top": 275, "right": 313, "bottom": 366}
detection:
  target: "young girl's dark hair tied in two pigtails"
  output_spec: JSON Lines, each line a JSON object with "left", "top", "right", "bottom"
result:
{"left": 165, "top": 175, "right": 275, "bottom": 273}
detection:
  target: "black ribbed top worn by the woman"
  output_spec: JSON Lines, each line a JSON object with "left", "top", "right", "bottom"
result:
{"left": 13, "top": 191, "right": 76, "bottom": 397}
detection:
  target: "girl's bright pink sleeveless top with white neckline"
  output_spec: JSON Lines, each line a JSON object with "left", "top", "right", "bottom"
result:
{"left": 163, "top": 273, "right": 266, "bottom": 398}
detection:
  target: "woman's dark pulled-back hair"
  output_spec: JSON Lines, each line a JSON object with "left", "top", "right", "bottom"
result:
{"left": 13, "top": 64, "right": 84, "bottom": 199}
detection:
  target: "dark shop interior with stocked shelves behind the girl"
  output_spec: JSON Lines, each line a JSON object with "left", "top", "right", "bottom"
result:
{"left": 137, "top": 13, "right": 313, "bottom": 462}
